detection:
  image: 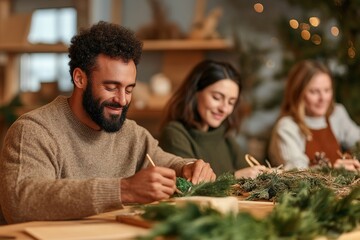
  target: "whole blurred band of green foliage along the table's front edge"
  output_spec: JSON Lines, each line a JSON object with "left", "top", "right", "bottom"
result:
{"left": 139, "top": 186, "right": 360, "bottom": 240}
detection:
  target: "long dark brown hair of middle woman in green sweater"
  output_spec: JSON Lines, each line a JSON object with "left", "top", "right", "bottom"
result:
{"left": 162, "top": 60, "right": 242, "bottom": 132}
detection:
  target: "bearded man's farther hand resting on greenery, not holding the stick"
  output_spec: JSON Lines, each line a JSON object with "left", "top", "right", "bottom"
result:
{"left": 182, "top": 159, "right": 216, "bottom": 184}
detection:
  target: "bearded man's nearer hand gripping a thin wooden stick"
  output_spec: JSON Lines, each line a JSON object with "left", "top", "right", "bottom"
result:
{"left": 120, "top": 167, "right": 176, "bottom": 204}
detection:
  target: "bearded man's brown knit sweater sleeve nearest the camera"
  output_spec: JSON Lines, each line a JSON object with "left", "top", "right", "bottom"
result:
{"left": 0, "top": 119, "right": 122, "bottom": 223}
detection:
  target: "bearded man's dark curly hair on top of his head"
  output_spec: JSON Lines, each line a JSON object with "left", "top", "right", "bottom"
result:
{"left": 68, "top": 21, "right": 143, "bottom": 82}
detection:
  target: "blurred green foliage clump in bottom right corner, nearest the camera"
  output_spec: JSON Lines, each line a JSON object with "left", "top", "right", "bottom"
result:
{"left": 269, "top": 186, "right": 360, "bottom": 239}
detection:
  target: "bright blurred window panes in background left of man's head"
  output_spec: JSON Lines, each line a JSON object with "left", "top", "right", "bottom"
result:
{"left": 20, "top": 8, "right": 77, "bottom": 92}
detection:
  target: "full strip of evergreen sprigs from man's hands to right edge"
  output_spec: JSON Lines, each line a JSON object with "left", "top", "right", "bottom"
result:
{"left": 174, "top": 166, "right": 360, "bottom": 201}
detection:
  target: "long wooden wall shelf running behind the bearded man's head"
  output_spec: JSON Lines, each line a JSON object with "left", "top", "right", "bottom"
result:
{"left": 0, "top": 39, "right": 233, "bottom": 54}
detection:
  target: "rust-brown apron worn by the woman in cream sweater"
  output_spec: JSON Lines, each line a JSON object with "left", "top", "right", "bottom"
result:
{"left": 305, "top": 119, "right": 341, "bottom": 166}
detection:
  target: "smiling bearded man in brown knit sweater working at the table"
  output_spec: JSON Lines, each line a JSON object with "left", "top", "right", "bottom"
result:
{"left": 0, "top": 22, "right": 215, "bottom": 223}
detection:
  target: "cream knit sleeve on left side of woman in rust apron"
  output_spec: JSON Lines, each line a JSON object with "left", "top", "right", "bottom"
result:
{"left": 269, "top": 117, "right": 309, "bottom": 169}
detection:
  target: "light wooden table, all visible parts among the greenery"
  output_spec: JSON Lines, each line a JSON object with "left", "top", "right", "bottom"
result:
{"left": 0, "top": 201, "right": 360, "bottom": 240}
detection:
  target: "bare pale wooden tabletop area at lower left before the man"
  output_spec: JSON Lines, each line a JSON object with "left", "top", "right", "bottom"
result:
{"left": 0, "top": 209, "right": 149, "bottom": 240}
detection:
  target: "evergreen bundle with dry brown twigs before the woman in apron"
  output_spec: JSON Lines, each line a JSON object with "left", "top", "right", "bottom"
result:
{"left": 234, "top": 167, "right": 360, "bottom": 201}
